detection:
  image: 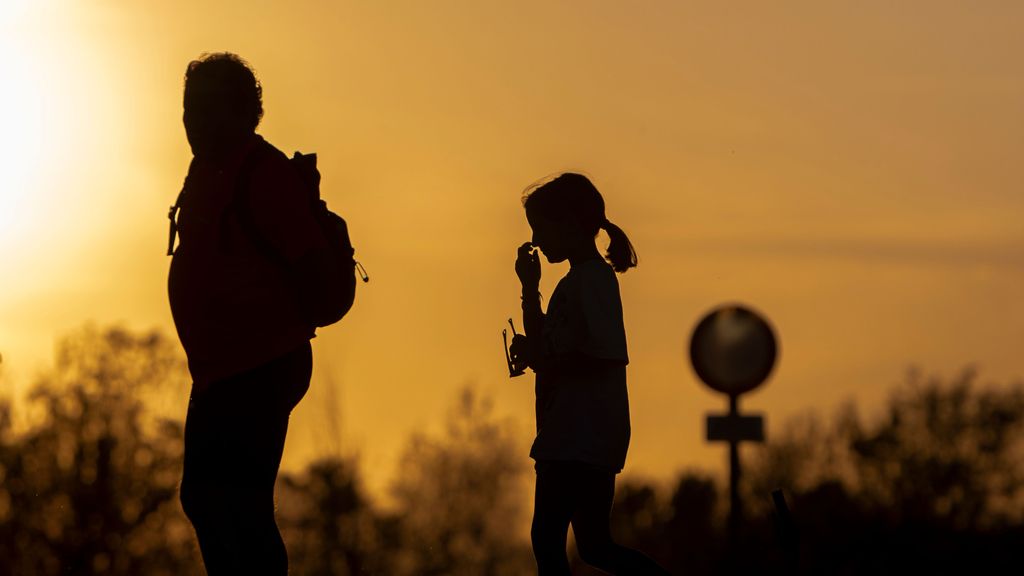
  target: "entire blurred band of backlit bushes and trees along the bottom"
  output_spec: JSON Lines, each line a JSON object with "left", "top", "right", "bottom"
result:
{"left": 0, "top": 326, "right": 1024, "bottom": 576}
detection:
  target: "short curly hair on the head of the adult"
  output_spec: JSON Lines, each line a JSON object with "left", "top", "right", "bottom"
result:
{"left": 185, "top": 52, "right": 263, "bottom": 130}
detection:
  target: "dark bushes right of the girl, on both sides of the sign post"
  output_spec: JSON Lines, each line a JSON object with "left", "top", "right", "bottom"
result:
{"left": 573, "top": 370, "right": 1024, "bottom": 575}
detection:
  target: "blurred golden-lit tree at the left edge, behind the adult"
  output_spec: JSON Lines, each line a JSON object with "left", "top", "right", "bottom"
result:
{"left": 0, "top": 327, "right": 197, "bottom": 575}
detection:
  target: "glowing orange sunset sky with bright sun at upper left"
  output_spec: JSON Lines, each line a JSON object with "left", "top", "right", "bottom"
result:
{"left": 0, "top": 0, "right": 1024, "bottom": 494}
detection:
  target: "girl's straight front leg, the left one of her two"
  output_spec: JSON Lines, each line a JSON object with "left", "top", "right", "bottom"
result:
{"left": 530, "top": 461, "right": 575, "bottom": 576}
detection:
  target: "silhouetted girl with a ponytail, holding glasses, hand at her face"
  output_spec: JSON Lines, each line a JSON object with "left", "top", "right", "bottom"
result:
{"left": 511, "top": 173, "right": 667, "bottom": 576}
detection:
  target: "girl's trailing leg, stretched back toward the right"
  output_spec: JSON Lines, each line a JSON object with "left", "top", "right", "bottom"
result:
{"left": 572, "top": 468, "right": 669, "bottom": 576}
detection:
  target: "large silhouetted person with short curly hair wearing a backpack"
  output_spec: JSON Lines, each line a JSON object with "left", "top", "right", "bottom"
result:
{"left": 168, "top": 53, "right": 342, "bottom": 575}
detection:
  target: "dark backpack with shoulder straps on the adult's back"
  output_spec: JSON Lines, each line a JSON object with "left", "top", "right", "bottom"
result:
{"left": 167, "top": 147, "right": 370, "bottom": 328}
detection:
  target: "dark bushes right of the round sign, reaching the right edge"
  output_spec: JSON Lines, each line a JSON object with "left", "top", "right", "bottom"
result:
{"left": 748, "top": 369, "right": 1024, "bottom": 574}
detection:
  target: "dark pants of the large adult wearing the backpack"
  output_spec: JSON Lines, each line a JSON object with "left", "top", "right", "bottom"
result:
{"left": 180, "top": 342, "right": 312, "bottom": 576}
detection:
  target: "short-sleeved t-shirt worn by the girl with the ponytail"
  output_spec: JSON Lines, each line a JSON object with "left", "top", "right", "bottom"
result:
{"left": 529, "top": 258, "right": 630, "bottom": 471}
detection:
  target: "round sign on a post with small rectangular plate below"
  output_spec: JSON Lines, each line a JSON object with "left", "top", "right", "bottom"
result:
{"left": 690, "top": 304, "right": 777, "bottom": 557}
